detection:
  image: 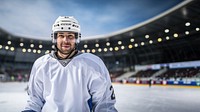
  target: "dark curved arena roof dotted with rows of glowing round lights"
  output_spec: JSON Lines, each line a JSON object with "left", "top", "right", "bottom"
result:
{"left": 0, "top": 0, "right": 200, "bottom": 71}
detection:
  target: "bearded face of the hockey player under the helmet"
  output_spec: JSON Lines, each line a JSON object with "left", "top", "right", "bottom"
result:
{"left": 57, "top": 32, "right": 76, "bottom": 53}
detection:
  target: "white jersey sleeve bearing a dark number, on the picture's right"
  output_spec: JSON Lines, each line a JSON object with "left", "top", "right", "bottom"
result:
{"left": 90, "top": 58, "right": 117, "bottom": 112}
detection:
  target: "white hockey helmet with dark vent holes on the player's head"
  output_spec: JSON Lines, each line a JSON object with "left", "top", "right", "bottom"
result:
{"left": 52, "top": 16, "right": 81, "bottom": 44}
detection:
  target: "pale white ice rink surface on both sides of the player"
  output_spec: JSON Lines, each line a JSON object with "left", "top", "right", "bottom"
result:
{"left": 0, "top": 82, "right": 200, "bottom": 112}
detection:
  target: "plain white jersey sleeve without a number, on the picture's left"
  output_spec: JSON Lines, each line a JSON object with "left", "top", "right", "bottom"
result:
{"left": 24, "top": 63, "right": 44, "bottom": 112}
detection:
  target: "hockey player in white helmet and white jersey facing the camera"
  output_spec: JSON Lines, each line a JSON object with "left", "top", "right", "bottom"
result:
{"left": 23, "top": 16, "right": 117, "bottom": 112}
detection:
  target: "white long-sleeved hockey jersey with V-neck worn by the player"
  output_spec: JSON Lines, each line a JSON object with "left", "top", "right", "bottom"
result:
{"left": 25, "top": 53, "right": 117, "bottom": 112}
